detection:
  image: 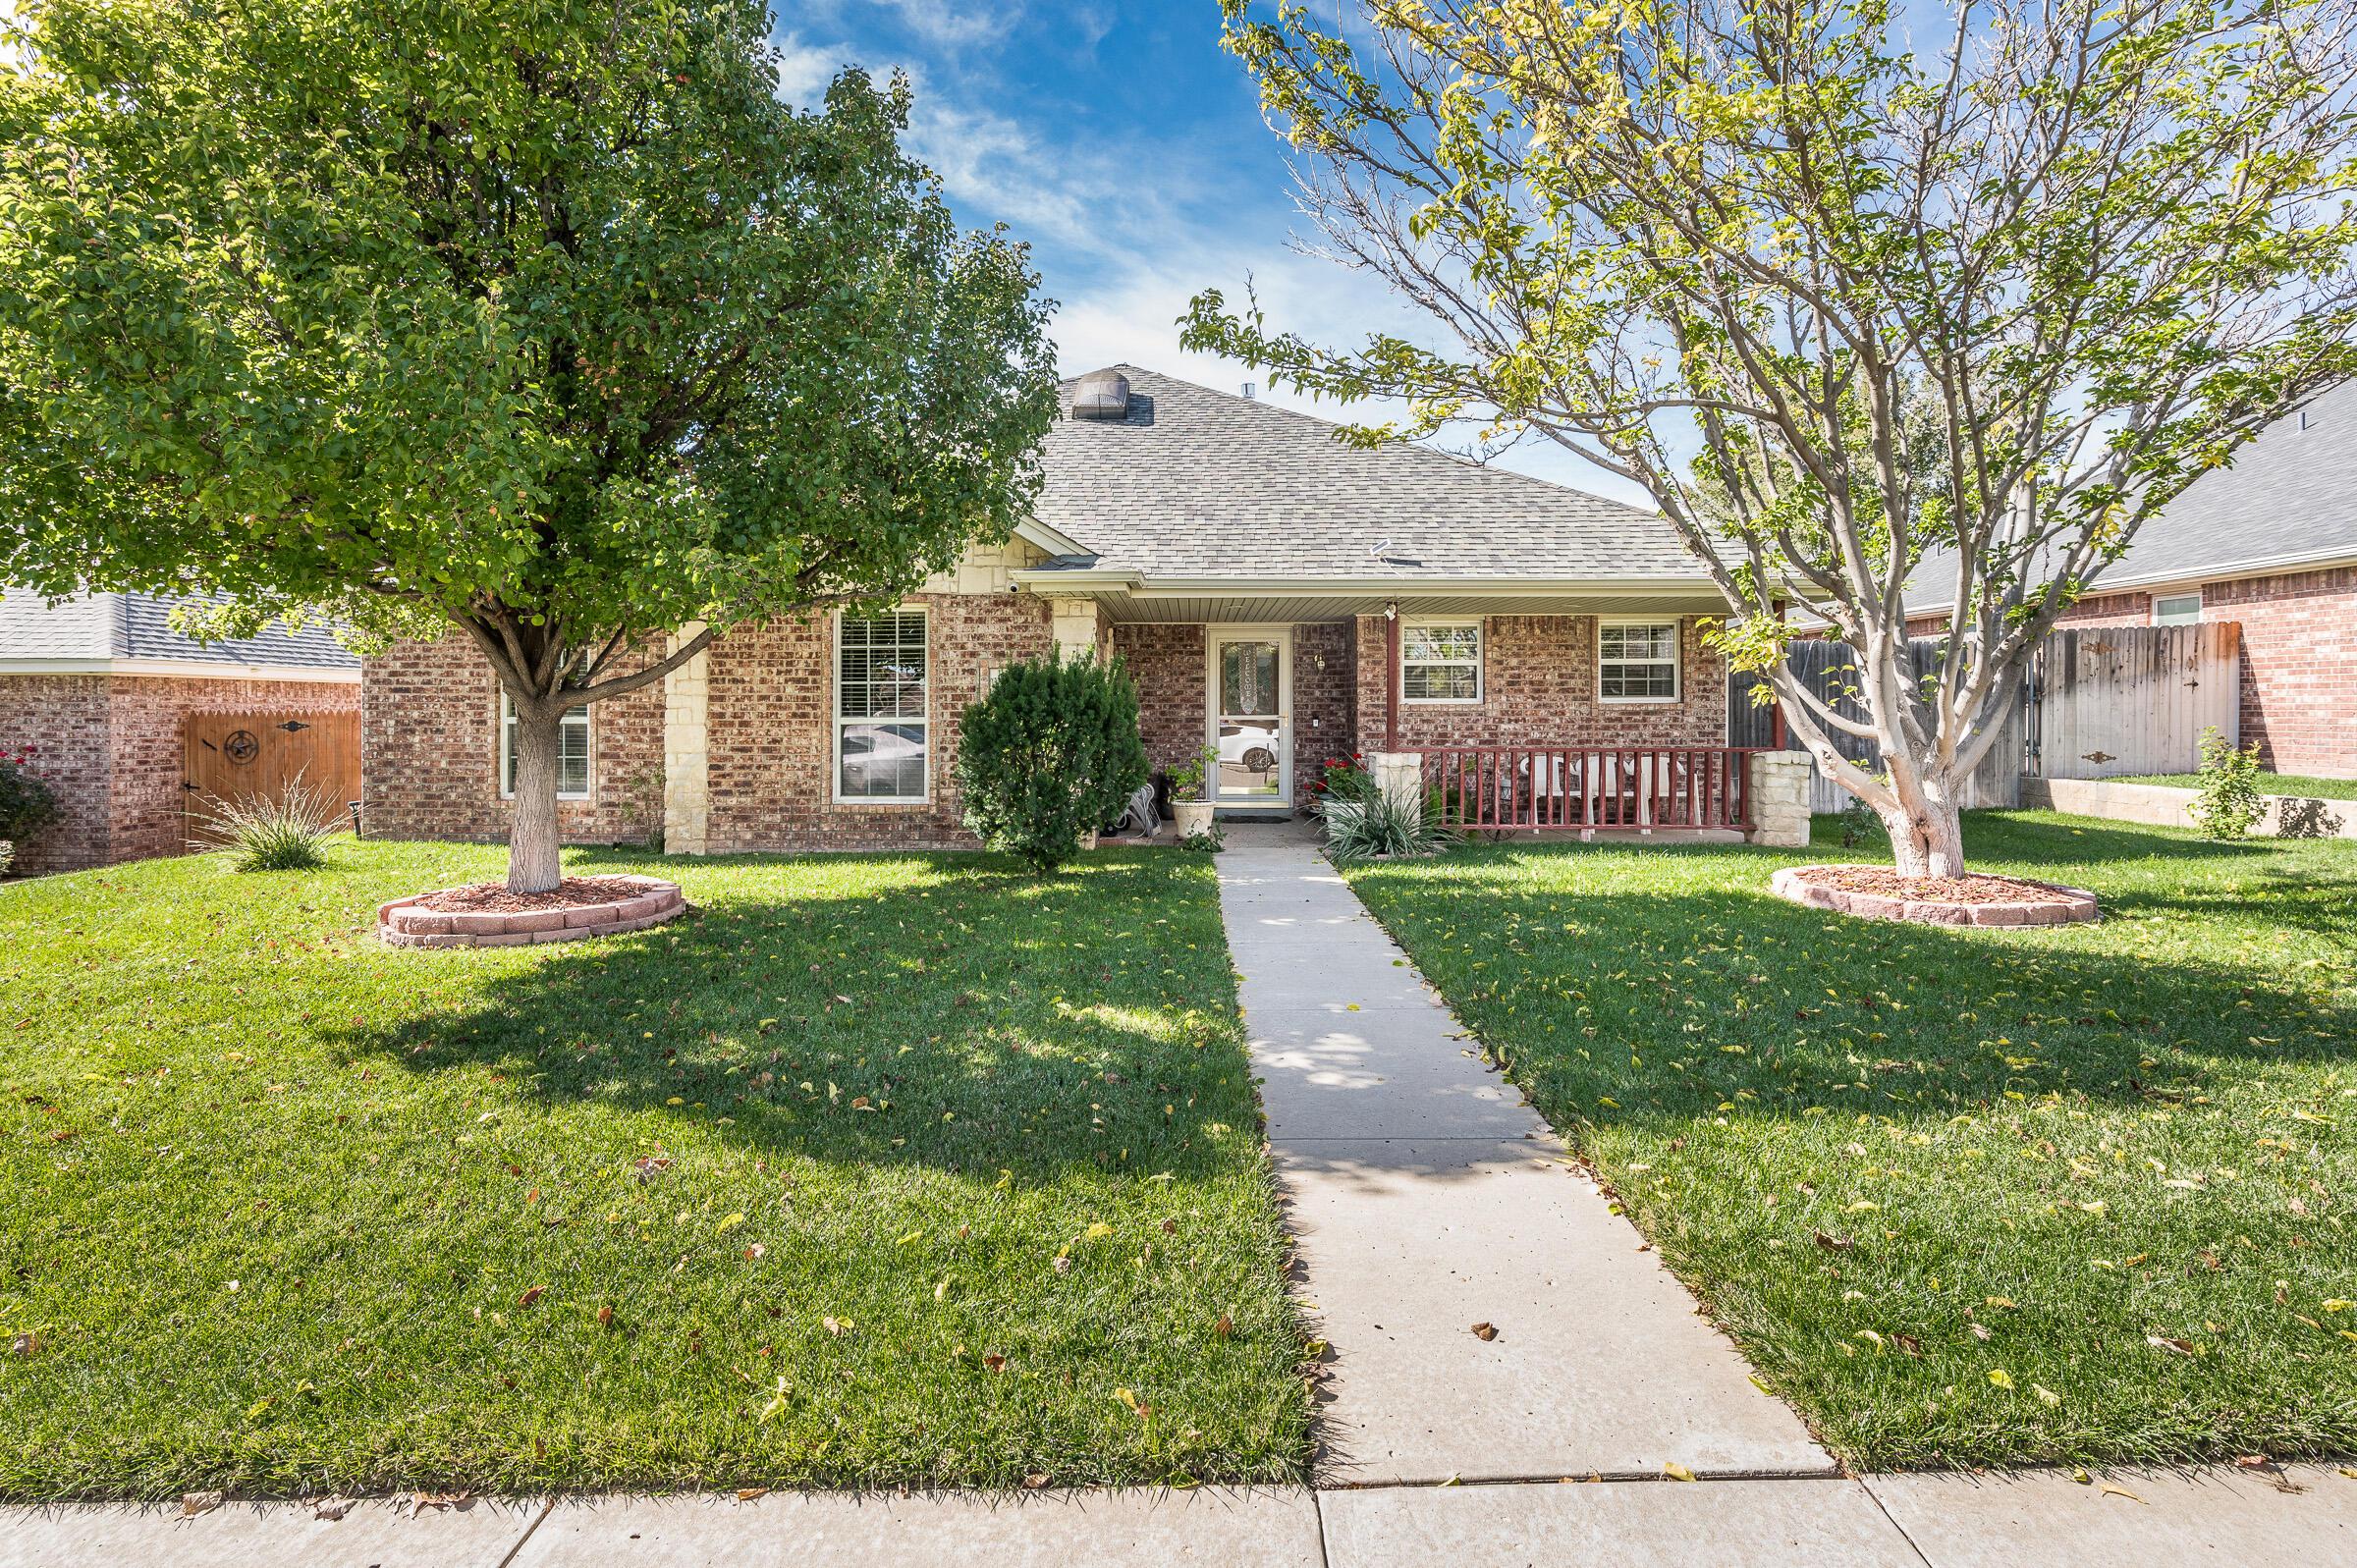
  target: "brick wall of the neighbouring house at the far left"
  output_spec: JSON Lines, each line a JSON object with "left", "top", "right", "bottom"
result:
{"left": 0, "top": 675, "right": 360, "bottom": 873}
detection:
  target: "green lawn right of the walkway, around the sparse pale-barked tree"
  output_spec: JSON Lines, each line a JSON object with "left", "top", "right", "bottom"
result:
{"left": 1350, "top": 814, "right": 2357, "bottom": 1467}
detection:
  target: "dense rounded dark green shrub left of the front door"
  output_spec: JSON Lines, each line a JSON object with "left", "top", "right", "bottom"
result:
{"left": 957, "top": 653, "right": 1145, "bottom": 873}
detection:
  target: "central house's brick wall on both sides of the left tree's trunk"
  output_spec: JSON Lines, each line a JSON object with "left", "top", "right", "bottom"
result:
{"left": 360, "top": 632, "right": 662, "bottom": 844}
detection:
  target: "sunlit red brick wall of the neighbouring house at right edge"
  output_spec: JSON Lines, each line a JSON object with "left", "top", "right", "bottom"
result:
{"left": 2202, "top": 566, "right": 2357, "bottom": 776}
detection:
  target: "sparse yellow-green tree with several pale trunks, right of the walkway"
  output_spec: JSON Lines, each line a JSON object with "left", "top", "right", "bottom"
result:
{"left": 1185, "top": 0, "right": 2357, "bottom": 875}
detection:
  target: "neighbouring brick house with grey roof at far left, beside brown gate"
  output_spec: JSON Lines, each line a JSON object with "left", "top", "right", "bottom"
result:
{"left": 0, "top": 589, "right": 360, "bottom": 873}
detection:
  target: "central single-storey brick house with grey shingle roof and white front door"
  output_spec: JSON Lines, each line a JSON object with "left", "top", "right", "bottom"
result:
{"left": 363, "top": 365, "right": 1772, "bottom": 851}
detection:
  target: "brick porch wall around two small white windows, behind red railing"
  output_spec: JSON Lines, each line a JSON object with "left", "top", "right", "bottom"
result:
{"left": 1355, "top": 616, "right": 1727, "bottom": 752}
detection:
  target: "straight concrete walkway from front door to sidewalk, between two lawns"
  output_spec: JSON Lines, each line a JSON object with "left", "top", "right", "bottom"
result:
{"left": 1219, "top": 833, "right": 1836, "bottom": 1486}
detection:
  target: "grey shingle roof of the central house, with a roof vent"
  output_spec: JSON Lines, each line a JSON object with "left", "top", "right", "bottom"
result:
{"left": 1032, "top": 365, "right": 1704, "bottom": 582}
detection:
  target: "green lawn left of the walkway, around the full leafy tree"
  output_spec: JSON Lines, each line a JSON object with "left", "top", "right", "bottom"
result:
{"left": 0, "top": 839, "right": 1308, "bottom": 1497}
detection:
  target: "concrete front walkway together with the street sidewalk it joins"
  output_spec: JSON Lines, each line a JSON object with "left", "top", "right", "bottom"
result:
{"left": 0, "top": 828, "right": 2357, "bottom": 1568}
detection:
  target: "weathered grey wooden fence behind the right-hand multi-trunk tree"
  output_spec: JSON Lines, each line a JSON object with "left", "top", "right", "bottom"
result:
{"left": 1727, "top": 622, "right": 2241, "bottom": 811}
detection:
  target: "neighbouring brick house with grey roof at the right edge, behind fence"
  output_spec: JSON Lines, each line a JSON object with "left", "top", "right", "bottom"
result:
{"left": 1909, "top": 382, "right": 2357, "bottom": 778}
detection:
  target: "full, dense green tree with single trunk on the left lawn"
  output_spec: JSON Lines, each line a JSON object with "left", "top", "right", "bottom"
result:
{"left": 0, "top": 0, "right": 1056, "bottom": 892}
